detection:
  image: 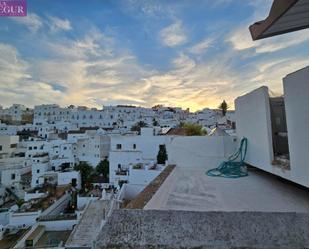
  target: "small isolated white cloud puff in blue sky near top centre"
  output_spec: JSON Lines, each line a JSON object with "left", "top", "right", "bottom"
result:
{"left": 160, "top": 21, "right": 187, "bottom": 47}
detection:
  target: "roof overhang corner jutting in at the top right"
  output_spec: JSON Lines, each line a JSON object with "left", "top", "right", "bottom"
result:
{"left": 249, "top": 0, "right": 309, "bottom": 40}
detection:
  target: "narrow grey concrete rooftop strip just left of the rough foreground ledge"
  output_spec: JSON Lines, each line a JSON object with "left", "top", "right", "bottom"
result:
{"left": 66, "top": 200, "right": 109, "bottom": 248}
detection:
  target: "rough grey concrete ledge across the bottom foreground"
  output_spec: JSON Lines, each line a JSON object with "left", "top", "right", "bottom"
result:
{"left": 96, "top": 210, "right": 309, "bottom": 249}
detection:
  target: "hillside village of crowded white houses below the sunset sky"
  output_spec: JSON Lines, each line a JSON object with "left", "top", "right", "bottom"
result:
{"left": 0, "top": 104, "right": 235, "bottom": 247}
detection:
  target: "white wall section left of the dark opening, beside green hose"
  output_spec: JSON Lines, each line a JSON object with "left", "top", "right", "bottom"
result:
{"left": 235, "top": 86, "right": 274, "bottom": 171}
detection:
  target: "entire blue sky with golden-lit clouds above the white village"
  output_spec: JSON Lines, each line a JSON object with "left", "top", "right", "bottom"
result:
{"left": 0, "top": 0, "right": 309, "bottom": 111}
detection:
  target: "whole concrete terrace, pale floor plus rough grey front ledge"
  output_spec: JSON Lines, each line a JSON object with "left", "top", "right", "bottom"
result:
{"left": 96, "top": 164, "right": 309, "bottom": 249}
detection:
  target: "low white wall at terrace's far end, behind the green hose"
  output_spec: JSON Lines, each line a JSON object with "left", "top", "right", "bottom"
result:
{"left": 167, "top": 136, "right": 238, "bottom": 169}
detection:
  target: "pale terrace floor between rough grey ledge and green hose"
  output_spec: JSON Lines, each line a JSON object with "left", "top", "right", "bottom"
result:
{"left": 144, "top": 167, "right": 309, "bottom": 213}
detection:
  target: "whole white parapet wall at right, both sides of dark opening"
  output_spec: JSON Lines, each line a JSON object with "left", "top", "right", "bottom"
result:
{"left": 235, "top": 67, "right": 309, "bottom": 187}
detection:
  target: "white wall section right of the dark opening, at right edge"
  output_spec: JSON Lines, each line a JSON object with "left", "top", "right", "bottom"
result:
{"left": 283, "top": 67, "right": 309, "bottom": 187}
